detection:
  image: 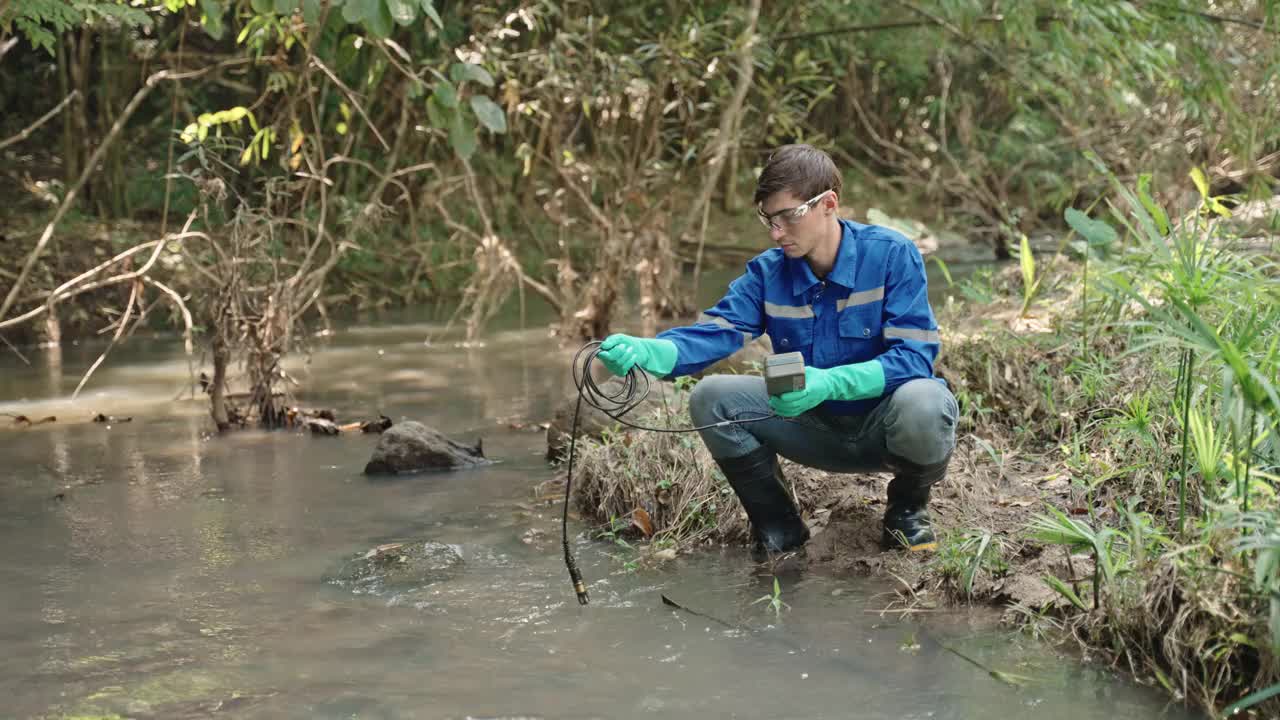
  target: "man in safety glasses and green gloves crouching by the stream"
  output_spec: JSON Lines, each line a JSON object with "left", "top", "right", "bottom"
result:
{"left": 596, "top": 145, "right": 957, "bottom": 552}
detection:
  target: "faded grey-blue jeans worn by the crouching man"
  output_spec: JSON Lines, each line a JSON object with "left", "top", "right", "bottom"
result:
{"left": 689, "top": 375, "right": 960, "bottom": 473}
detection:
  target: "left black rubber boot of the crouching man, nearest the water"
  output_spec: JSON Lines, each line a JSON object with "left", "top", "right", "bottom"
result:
{"left": 716, "top": 446, "right": 809, "bottom": 552}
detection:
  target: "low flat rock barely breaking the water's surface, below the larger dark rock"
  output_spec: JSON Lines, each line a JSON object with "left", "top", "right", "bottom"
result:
{"left": 326, "top": 541, "right": 462, "bottom": 596}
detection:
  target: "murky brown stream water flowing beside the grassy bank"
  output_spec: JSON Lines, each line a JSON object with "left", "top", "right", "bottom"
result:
{"left": 0, "top": 283, "right": 1190, "bottom": 720}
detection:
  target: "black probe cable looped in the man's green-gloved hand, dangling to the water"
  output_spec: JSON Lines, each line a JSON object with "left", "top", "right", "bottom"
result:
{"left": 561, "top": 340, "right": 778, "bottom": 605}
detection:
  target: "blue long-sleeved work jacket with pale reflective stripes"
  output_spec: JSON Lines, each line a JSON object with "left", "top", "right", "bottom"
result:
{"left": 658, "top": 220, "right": 941, "bottom": 415}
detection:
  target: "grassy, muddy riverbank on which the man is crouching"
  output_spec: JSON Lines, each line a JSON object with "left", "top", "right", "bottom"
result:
{"left": 575, "top": 195, "right": 1280, "bottom": 716}
